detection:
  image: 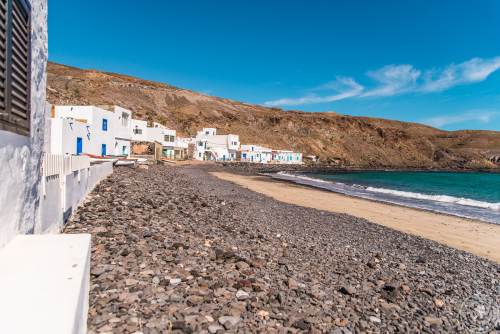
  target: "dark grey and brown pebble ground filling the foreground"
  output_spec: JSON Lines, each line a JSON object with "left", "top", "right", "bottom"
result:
{"left": 66, "top": 166, "right": 500, "bottom": 334}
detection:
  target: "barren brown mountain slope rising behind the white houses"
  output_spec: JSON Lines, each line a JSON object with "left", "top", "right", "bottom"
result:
{"left": 48, "top": 63, "right": 500, "bottom": 168}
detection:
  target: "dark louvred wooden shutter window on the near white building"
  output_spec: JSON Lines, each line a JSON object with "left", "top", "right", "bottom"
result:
{"left": 0, "top": 0, "right": 31, "bottom": 135}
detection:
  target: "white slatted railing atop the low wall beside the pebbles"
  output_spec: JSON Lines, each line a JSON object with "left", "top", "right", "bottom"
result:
{"left": 42, "top": 153, "right": 90, "bottom": 177}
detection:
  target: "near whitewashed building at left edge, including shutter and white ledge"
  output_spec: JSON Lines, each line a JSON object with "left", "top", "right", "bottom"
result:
{"left": 0, "top": 0, "right": 96, "bottom": 334}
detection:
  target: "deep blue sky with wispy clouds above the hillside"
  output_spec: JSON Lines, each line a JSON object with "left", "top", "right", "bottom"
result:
{"left": 49, "top": 0, "right": 500, "bottom": 131}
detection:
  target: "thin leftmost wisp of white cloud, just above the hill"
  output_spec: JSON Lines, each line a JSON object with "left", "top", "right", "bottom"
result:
{"left": 264, "top": 77, "right": 364, "bottom": 107}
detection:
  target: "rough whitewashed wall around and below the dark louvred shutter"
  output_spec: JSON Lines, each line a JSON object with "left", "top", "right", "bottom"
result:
{"left": 0, "top": 0, "right": 48, "bottom": 248}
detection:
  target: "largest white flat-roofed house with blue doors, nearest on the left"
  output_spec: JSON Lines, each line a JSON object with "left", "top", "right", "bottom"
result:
{"left": 51, "top": 106, "right": 132, "bottom": 156}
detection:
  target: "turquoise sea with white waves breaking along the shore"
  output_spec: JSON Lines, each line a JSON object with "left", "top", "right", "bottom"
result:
{"left": 272, "top": 171, "right": 500, "bottom": 224}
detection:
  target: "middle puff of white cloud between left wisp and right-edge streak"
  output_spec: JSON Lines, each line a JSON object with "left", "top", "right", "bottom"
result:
{"left": 362, "top": 64, "right": 421, "bottom": 96}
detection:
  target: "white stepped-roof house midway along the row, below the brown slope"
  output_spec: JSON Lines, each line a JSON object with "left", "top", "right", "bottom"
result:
{"left": 193, "top": 128, "right": 240, "bottom": 161}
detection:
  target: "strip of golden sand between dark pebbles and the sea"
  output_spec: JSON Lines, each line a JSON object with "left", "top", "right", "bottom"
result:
{"left": 212, "top": 172, "right": 500, "bottom": 263}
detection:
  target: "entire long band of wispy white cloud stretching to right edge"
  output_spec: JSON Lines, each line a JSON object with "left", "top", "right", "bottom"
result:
{"left": 265, "top": 57, "right": 500, "bottom": 107}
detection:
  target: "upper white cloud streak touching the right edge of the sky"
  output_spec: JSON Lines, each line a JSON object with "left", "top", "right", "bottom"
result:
{"left": 420, "top": 57, "right": 500, "bottom": 92}
